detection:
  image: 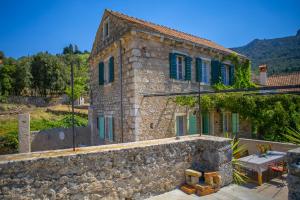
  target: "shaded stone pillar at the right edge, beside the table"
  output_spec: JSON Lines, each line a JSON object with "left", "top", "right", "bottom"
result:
{"left": 287, "top": 148, "right": 300, "bottom": 200}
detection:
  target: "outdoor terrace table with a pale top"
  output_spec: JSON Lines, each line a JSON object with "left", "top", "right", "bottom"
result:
{"left": 238, "top": 151, "right": 286, "bottom": 185}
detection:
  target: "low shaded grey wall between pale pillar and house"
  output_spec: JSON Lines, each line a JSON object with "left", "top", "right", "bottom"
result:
{"left": 31, "top": 127, "right": 91, "bottom": 151}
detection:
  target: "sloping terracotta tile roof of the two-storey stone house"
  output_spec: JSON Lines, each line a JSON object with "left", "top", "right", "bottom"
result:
{"left": 108, "top": 10, "right": 241, "bottom": 57}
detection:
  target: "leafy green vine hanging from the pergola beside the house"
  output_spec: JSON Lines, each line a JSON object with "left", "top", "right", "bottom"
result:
{"left": 175, "top": 93, "right": 300, "bottom": 141}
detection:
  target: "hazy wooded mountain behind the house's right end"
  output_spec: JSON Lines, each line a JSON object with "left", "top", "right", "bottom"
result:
{"left": 232, "top": 29, "right": 300, "bottom": 75}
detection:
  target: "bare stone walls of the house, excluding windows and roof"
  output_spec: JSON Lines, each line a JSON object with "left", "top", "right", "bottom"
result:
{"left": 90, "top": 11, "right": 251, "bottom": 144}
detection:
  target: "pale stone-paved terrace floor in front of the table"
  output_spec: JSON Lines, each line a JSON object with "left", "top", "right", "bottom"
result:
{"left": 147, "top": 179, "right": 288, "bottom": 200}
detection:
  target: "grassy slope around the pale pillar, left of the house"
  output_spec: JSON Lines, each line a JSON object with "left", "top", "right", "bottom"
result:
{"left": 0, "top": 105, "right": 88, "bottom": 155}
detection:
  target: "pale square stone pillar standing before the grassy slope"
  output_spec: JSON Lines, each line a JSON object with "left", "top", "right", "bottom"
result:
{"left": 18, "top": 113, "right": 31, "bottom": 153}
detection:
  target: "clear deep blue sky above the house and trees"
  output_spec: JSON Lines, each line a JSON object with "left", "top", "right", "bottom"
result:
{"left": 0, "top": 0, "right": 300, "bottom": 58}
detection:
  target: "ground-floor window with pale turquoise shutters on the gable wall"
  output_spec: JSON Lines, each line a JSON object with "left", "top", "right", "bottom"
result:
{"left": 98, "top": 115, "right": 114, "bottom": 142}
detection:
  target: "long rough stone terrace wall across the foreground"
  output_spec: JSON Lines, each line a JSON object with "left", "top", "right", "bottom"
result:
{"left": 0, "top": 136, "right": 232, "bottom": 199}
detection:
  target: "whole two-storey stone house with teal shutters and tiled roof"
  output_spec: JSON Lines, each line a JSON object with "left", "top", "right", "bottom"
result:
{"left": 89, "top": 10, "right": 251, "bottom": 145}
